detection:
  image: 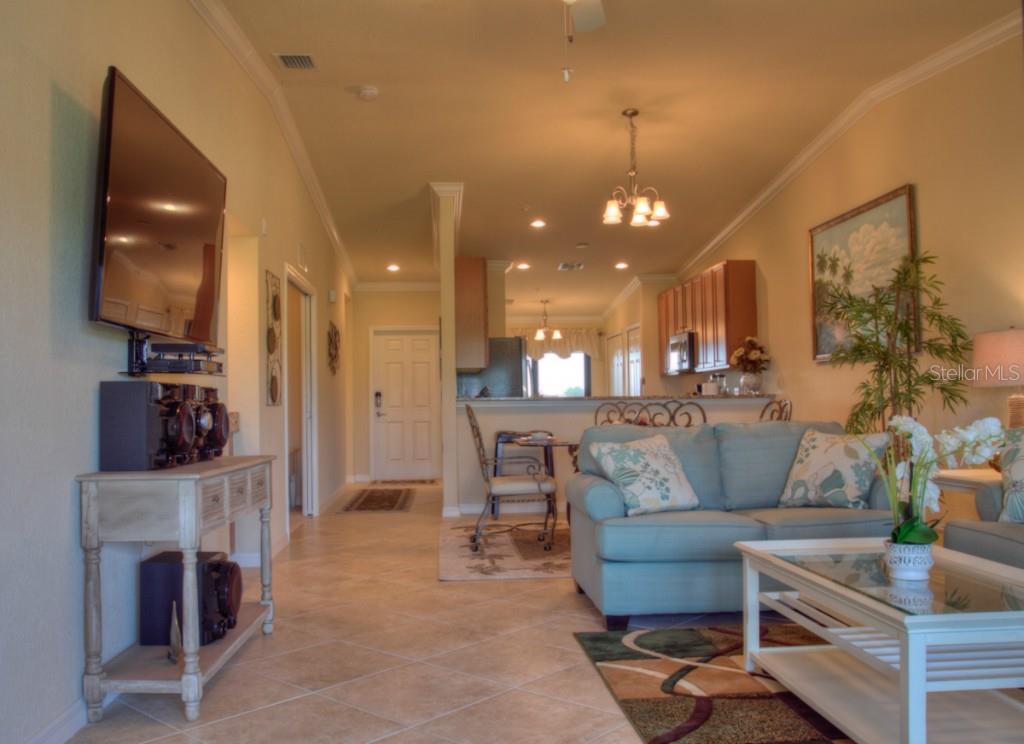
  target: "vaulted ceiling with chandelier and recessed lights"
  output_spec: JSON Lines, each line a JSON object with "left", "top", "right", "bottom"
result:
{"left": 225, "top": 0, "right": 1018, "bottom": 315}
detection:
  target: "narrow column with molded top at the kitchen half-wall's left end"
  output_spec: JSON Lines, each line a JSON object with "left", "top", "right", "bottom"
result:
{"left": 430, "top": 183, "right": 462, "bottom": 517}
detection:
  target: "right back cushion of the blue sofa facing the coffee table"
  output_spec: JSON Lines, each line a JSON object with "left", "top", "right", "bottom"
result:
{"left": 716, "top": 421, "right": 843, "bottom": 510}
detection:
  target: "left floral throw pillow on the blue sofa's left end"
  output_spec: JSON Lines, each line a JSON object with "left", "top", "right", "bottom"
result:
{"left": 590, "top": 434, "right": 700, "bottom": 517}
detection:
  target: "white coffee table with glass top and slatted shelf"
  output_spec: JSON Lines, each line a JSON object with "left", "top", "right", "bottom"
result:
{"left": 736, "top": 538, "right": 1024, "bottom": 744}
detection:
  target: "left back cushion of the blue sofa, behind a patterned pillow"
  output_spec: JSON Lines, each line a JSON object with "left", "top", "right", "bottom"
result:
{"left": 578, "top": 424, "right": 725, "bottom": 509}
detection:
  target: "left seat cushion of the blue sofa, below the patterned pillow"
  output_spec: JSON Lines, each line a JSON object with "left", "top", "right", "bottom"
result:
{"left": 597, "top": 511, "right": 765, "bottom": 562}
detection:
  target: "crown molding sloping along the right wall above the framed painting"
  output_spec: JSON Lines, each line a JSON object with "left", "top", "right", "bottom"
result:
{"left": 679, "top": 10, "right": 1022, "bottom": 274}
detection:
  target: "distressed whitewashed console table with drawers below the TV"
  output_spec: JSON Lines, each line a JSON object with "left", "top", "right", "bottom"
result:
{"left": 76, "top": 455, "right": 273, "bottom": 721}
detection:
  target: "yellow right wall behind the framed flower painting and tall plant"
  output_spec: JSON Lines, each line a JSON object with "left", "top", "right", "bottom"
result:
{"left": 682, "top": 37, "right": 1024, "bottom": 427}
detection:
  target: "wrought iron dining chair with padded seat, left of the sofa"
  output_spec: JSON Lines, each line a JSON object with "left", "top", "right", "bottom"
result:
{"left": 466, "top": 405, "right": 558, "bottom": 553}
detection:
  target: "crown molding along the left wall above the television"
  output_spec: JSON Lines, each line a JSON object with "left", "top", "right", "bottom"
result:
{"left": 190, "top": 0, "right": 358, "bottom": 283}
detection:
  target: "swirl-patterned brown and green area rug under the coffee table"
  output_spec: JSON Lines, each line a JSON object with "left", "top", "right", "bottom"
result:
{"left": 577, "top": 623, "right": 852, "bottom": 744}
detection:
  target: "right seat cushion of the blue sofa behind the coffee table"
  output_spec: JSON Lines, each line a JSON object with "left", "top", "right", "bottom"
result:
{"left": 731, "top": 507, "right": 893, "bottom": 540}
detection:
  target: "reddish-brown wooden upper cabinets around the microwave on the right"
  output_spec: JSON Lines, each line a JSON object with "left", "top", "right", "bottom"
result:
{"left": 657, "top": 261, "right": 758, "bottom": 373}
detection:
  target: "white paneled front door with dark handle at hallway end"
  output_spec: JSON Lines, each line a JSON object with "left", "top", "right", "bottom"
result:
{"left": 370, "top": 331, "right": 441, "bottom": 480}
